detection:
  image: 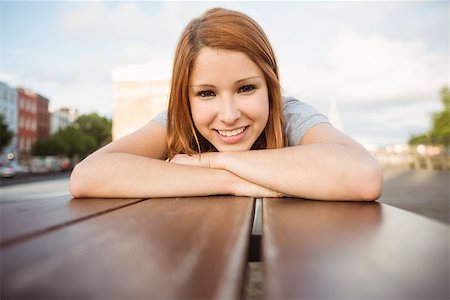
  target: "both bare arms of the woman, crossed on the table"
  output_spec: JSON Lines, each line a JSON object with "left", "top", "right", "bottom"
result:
{"left": 71, "top": 122, "right": 382, "bottom": 200}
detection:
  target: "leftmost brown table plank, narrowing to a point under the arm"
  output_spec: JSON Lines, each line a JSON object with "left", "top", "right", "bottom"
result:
{"left": 0, "top": 195, "right": 141, "bottom": 247}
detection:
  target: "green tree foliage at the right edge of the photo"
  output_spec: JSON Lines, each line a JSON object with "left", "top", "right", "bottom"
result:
{"left": 409, "top": 86, "right": 450, "bottom": 148}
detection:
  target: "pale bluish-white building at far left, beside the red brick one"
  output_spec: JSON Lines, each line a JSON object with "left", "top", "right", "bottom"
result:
{"left": 0, "top": 82, "right": 18, "bottom": 158}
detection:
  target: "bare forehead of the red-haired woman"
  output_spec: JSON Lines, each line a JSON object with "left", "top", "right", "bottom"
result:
{"left": 190, "top": 47, "right": 262, "bottom": 84}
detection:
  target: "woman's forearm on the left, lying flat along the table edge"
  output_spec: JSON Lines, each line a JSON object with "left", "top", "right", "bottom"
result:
{"left": 70, "top": 153, "right": 236, "bottom": 198}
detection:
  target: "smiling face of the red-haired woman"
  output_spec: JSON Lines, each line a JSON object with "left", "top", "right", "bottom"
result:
{"left": 189, "top": 47, "right": 269, "bottom": 151}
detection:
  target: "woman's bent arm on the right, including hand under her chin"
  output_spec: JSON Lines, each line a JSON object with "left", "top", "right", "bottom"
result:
{"left": 175, "top": 123, "right": 382, "bottom": 200}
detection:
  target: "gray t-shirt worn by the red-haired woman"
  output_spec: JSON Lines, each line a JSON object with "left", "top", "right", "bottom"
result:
{"left": 152, "top": 97, "right": 329, "bottom": 146}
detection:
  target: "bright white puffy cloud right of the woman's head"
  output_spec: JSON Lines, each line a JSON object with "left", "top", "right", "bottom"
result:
{"left": 282, "top": 32, "right": 448, "bottom": 104}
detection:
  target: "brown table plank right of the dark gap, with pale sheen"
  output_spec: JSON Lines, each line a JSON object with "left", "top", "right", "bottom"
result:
{"left": 263, "top": 199, "right": 449, "bottom": 299}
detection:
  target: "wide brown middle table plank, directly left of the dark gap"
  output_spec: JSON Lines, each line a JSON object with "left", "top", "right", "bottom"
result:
{"left": 1, "top": 197, "right": 254, "bottom": 299}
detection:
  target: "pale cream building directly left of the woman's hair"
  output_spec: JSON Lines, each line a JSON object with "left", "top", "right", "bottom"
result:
{"left": 112, "top": 62, "right": 172, "bottom": 140}
